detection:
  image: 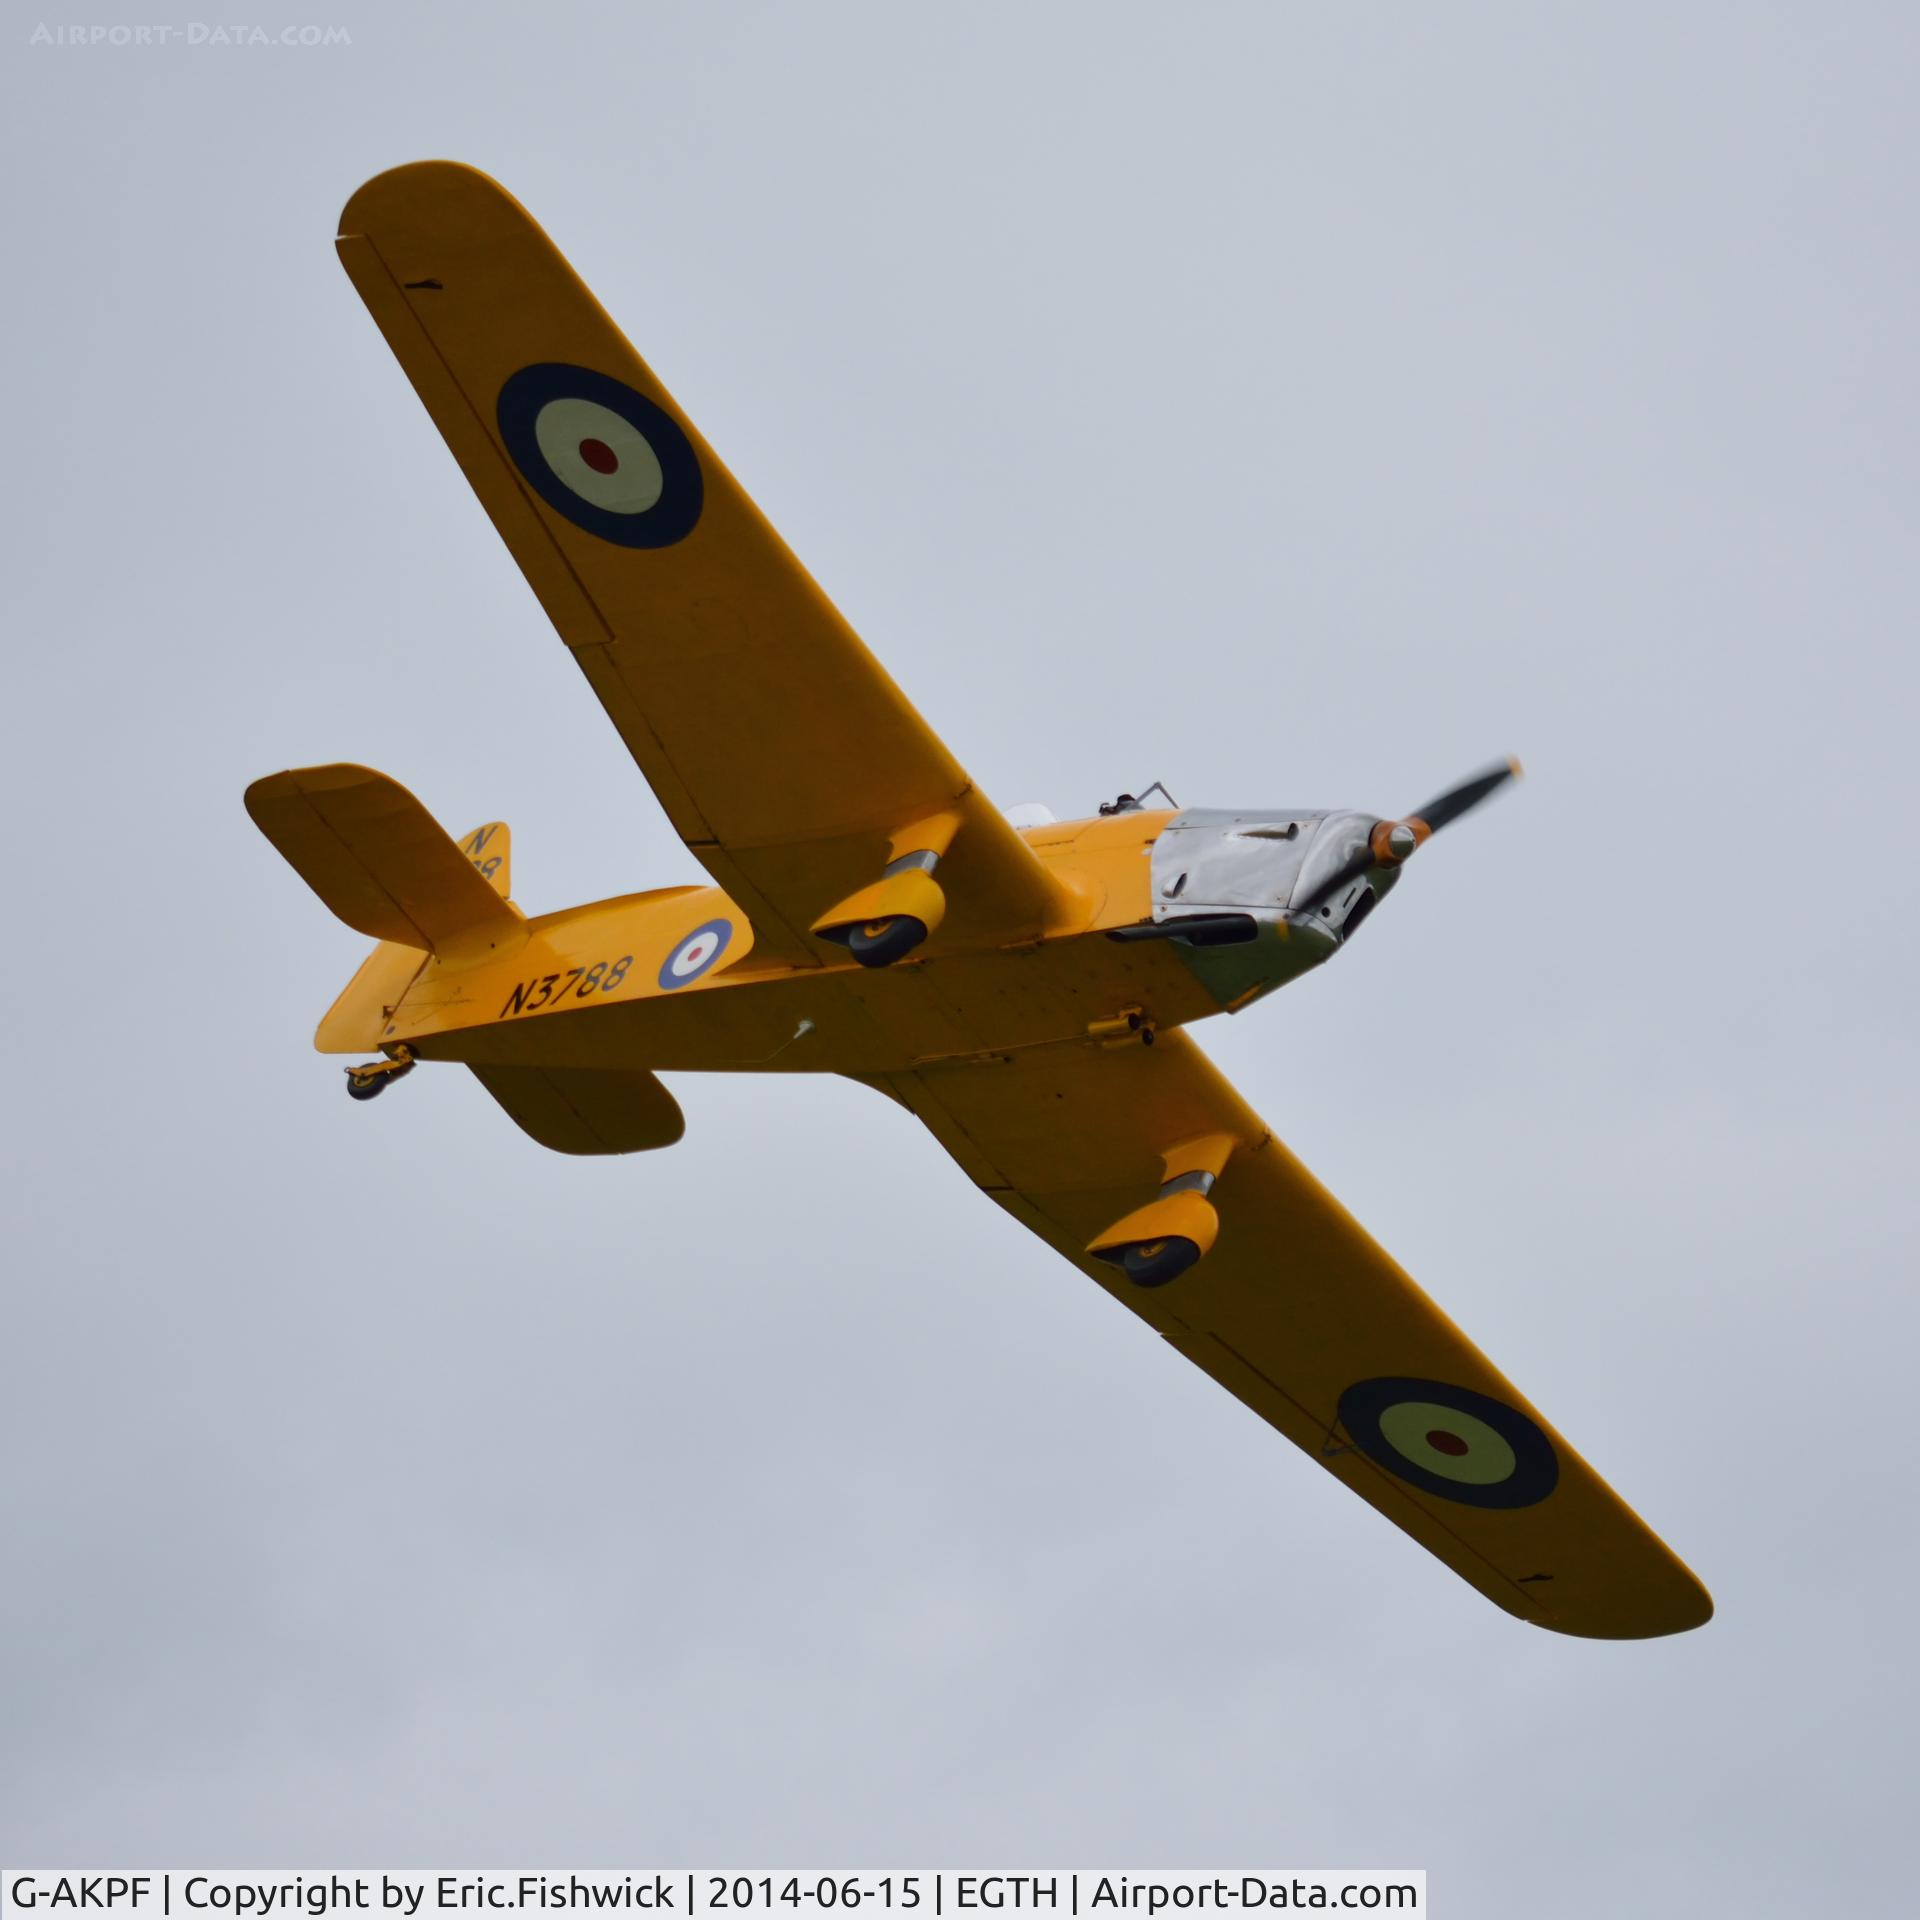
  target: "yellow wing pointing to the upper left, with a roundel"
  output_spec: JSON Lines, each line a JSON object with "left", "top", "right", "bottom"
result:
{"left": 340, "top": 161, "right": 1056, "bottom": 966}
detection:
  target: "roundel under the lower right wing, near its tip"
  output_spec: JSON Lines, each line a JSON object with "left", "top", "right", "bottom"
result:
{"left": 1340, "top": 1379, "right": 1559, "bottom": 1507}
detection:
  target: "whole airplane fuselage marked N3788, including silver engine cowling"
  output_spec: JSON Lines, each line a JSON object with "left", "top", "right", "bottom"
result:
{"left": 317, "top": 810, "right": 1390, "bottom": 1075}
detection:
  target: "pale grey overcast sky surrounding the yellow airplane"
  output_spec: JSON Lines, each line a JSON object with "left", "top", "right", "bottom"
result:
{"left": 0, "top": 0, "right": 1920, "bottom": 1920}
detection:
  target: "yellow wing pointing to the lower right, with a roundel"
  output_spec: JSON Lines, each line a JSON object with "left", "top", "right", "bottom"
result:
{"left": 881, "top": 1033, "right": 1713, "bottom": 1640}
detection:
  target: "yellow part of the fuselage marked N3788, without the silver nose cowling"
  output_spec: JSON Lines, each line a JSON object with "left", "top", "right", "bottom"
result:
{"left": 315, "top": 812, "right": 1274, "bottom": 1073}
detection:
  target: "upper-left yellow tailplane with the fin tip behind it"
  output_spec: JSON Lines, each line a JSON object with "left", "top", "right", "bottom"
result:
{"left": 246, "top": 766, "right": 526, "bottom": 966}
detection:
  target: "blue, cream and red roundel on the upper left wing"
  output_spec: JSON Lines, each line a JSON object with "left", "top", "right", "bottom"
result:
{"left": 497, "top": 361, "right": 701, "bottom": 547}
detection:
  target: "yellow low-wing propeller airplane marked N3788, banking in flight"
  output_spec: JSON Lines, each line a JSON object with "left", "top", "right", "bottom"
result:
{"left": 246, "top": 161, "right": 1713, "bottom": 1640}
